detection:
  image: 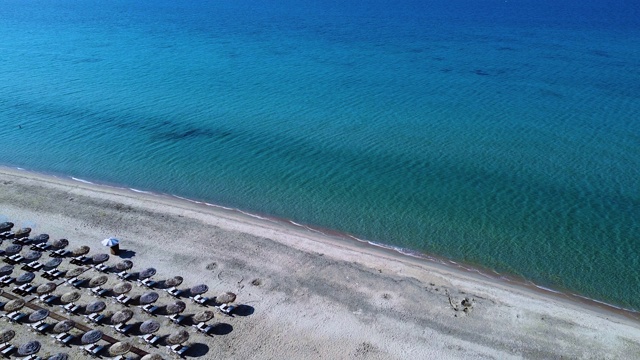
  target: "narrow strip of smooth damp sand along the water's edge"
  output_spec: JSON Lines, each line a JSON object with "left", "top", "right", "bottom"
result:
{"left": 0, "top": 165, "right": 640, "bottom": 323}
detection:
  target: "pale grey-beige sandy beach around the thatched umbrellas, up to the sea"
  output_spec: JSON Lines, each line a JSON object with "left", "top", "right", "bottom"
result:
{"left": 0, "top": 168, "right": 640, "bottom": 359}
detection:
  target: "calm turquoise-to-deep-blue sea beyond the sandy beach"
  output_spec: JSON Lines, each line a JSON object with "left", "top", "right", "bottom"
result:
{"left": 0, "top": 0, "right": 640, "bottom": 311}
